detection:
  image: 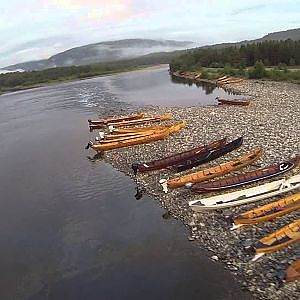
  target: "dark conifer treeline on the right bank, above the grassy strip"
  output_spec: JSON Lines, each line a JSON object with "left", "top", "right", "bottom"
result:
{"left": 170, "top": 39, "right": 300, "bottom": 71}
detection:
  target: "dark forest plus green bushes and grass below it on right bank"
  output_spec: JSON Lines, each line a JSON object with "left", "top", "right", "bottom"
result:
{"left": 170, "top": 40, "right": 300, "bottom": 83}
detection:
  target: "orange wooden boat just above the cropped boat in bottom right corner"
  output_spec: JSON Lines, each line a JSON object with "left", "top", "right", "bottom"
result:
{"left": 252, "top": 219, "right": 300, "bottom": 261}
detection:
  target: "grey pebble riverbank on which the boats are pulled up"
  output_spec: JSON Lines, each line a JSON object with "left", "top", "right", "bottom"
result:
{"left": 105, "top": 80, "right": 300, "bottom": 299}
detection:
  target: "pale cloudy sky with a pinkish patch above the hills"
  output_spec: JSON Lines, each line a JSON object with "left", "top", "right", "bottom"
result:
{"left": 0, "top": 0, "right": 300, "bottom": 68}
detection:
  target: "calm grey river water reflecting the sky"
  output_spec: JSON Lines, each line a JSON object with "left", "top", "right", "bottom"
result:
{"left": 0, "top": 68, "right": 250, "bottom": 300}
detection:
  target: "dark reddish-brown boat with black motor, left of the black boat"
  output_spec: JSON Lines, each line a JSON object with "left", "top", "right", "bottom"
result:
{"left": 131, "top": 138, "right": 226, "bottom": 175}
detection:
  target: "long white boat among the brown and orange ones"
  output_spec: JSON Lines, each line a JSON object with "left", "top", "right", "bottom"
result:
{"left": 189, "top": 174, "right": 300, "bottom": 211}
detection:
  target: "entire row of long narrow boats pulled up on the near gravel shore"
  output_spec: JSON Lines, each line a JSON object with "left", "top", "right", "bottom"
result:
{"left": 87, "top": 114, "right": 300, "bottom": 281}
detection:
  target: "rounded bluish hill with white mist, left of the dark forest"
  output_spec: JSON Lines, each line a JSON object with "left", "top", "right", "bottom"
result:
{"left": 4, "top": 39, "right": 194, "bottom": 71}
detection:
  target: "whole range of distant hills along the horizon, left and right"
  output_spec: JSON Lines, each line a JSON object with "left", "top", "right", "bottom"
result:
{"left": 0, "top": 28, "right": 300, "bottom": 73}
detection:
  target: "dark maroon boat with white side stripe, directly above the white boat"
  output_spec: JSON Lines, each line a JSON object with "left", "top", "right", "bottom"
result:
{"left": 191, "top": 155, "right": 300, "bottom": 193}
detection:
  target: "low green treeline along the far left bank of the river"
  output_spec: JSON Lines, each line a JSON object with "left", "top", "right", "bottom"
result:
{"left": 0, "top": 54, "right": 171, "bottom": 92}
